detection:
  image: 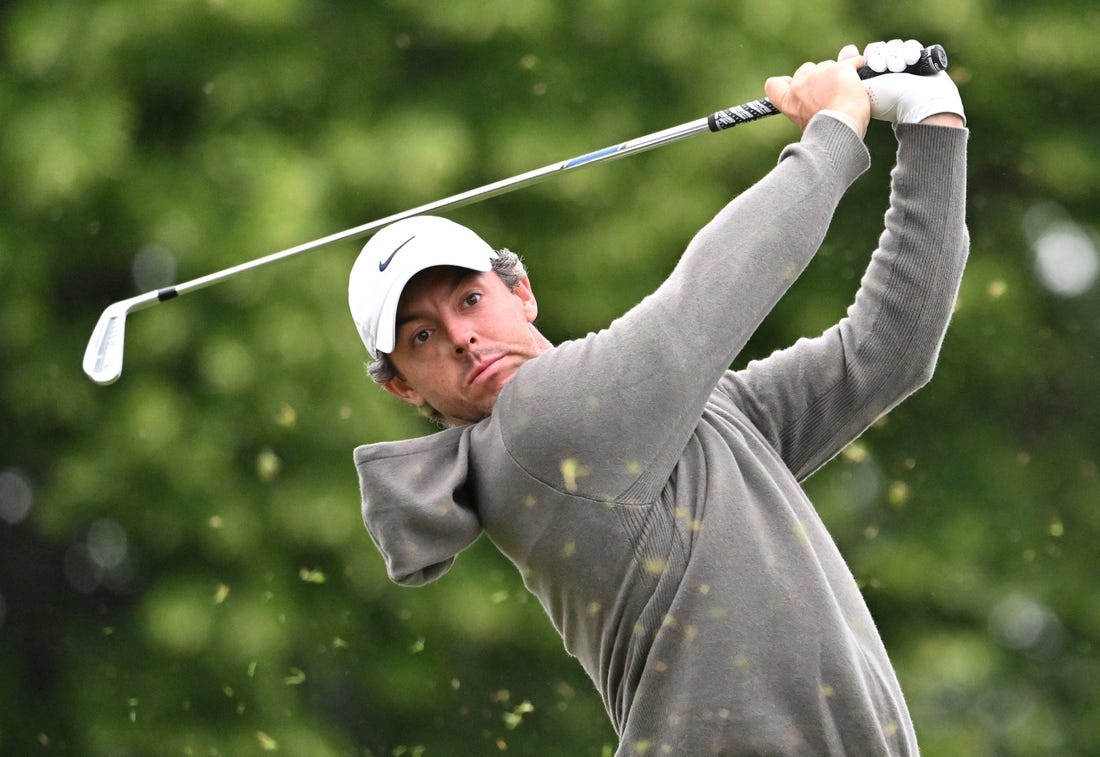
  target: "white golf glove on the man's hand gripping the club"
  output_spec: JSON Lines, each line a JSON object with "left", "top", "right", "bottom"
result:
{"left": 837, "top": 40, "right": 966, "bottom": 124}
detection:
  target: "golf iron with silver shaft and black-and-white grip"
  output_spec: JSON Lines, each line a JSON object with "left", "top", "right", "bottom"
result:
{"left": 84, "top": 45, "right": 947, "bottom": 384}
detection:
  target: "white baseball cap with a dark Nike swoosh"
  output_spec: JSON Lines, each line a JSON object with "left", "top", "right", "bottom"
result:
{"left": 348, "top": 216, "right": 497, "bottom": 359}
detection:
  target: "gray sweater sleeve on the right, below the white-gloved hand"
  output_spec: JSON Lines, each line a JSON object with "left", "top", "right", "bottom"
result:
{"left": 722, "top": 124, "right": 968, "bottom": 480}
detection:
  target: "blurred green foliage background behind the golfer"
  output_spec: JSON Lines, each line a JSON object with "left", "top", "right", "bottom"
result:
{"left": 0, "top": 0, "right": 1100, "bottom": 757}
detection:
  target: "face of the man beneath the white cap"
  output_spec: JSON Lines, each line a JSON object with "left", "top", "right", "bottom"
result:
{"left": 385, "top": 266, "right": 550, "bottom": 425}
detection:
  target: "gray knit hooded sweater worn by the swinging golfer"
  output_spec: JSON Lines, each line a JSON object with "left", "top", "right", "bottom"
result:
{"left": 354, "top": 114, "right": 968, "bottom": 756}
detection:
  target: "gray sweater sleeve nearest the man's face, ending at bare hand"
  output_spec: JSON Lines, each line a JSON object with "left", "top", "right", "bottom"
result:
{"left": 494, "top": 116, "right": 869, "bottom": 502}
